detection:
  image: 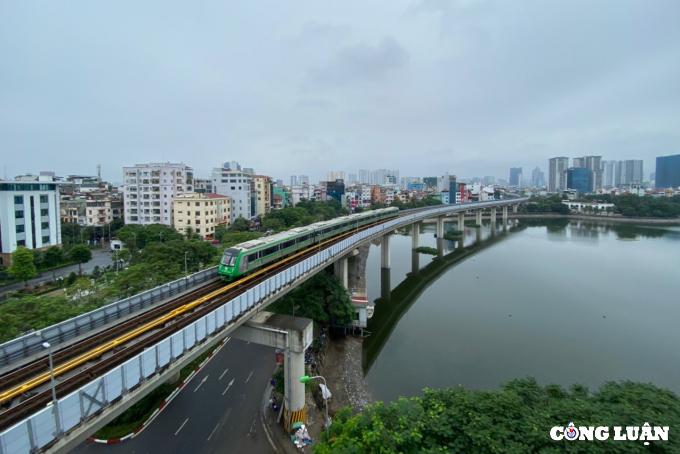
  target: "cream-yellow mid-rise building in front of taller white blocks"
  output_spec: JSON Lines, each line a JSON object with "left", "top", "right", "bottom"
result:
{"left": 172, "top": 193, "right": 232, "bottom": 239}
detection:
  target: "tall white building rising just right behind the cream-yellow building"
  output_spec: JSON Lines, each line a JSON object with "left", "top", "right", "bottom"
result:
{"left": 211, "top": 161, "right": 253, "bottom": 222}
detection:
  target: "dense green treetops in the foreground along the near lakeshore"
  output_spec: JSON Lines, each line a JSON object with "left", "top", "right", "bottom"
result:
{"left": 315, "top": 378, "right": 680, "bottom": 454}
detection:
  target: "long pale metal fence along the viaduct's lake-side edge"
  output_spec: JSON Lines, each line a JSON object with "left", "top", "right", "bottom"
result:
{"left": 0, "top": 199, "right": 523, "bottom": 454}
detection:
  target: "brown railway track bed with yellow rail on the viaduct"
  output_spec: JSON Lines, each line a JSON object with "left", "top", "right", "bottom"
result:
{"left": 0, "top": 220, "right": 394, "bottom": 430}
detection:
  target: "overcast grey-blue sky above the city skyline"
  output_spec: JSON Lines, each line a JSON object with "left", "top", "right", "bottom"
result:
{"left": 0, "top": 0, "right": 680, "bottom": 181}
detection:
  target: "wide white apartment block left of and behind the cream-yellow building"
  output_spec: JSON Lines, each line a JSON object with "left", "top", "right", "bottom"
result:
{"left": 123, "top": 162, "right": 194, "bottom": 225}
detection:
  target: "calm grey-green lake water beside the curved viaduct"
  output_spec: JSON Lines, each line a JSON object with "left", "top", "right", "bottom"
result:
{"left": 363, "top": 220, "right": 680, "bottom": 400}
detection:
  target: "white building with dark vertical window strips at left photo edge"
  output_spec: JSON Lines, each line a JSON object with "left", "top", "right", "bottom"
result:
{"left": 0, "top": 181, "right": 61, "bottom": 266}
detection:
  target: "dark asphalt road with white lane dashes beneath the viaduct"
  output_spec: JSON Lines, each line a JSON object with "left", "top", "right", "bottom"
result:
{"left": 73, "top": 339, "right": 275, "bottom": 454}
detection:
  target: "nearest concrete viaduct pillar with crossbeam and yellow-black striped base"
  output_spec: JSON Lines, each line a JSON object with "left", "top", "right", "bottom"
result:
{"left": 233, "top": 311, "right": 314, "bottom": 432}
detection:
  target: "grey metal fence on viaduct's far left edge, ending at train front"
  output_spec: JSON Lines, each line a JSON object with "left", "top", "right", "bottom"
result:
{"left": 0, "top": 266, "right": 217, "bottom": 367}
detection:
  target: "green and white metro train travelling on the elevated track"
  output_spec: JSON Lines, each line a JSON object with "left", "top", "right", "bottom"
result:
{"left": 218, "top": 208, "right": 399, "bottom": 281}
